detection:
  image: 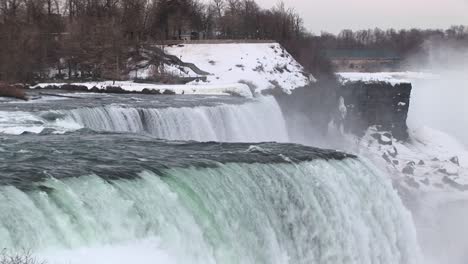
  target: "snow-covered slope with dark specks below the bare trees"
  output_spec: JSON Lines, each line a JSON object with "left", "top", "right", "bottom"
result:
{"left": 165, "top": 43, "right": 315, "bottom": 93}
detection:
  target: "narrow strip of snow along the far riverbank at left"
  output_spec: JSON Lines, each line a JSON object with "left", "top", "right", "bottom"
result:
{"left": 32, "top": 81, "right": 253, "bottom": 98}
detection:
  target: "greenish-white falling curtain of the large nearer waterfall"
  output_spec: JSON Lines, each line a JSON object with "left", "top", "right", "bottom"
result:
{"left": 0, "top": 160, "right": 419, "bottom": 264}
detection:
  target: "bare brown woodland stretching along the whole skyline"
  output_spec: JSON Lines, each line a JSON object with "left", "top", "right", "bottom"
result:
{"left": 0, "top": 0, "right": 468, "bottom": 82}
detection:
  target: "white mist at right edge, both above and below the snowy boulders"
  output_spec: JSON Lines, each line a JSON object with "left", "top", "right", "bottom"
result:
{"left": 408, "top": 40, "right": 468, "bottom": 264}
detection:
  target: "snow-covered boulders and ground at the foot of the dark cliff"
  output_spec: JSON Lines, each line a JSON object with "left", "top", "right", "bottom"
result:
{"left": 350, "top": 127, "right": 468, "bottom": 192}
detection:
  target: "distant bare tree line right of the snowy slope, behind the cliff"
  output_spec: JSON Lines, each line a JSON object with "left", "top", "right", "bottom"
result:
{"left": 292, "top": 25, "right": 468, "bottom": 74}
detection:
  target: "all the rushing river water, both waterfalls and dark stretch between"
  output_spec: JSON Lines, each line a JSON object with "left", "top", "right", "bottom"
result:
{"left": 0, "top": 92, "right": 419, "bottom": 264}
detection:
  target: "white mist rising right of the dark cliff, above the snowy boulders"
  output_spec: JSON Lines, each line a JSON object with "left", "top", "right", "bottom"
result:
{"left": 408, "top": 40, "right": 468, "bottom": 147}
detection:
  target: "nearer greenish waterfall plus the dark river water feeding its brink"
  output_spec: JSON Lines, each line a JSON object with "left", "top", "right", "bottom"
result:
{"left": 0, "top": 134, "right": 418, "bottom": 264}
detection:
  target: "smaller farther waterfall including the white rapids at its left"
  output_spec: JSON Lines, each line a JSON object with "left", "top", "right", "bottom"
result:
{"left": 0, "top": 97, "right": 290, "bottom": 142}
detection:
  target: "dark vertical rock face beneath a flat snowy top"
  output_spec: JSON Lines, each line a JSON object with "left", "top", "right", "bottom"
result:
{"left": 338, "top": 82, "right": 412, "bottom": 141}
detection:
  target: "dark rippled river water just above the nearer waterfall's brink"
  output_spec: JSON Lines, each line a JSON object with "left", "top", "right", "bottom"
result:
{"left": 0, "top": 130, "right": 356, "bottom": 189}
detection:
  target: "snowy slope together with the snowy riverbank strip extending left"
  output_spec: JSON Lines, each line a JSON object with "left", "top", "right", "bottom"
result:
{"left": 33, "top": 43, "right": 316, "bottom": 98}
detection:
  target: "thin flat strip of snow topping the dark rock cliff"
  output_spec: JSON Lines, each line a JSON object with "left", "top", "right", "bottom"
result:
{"left": 337, "top": 72, "right": 439, "bottom": 85}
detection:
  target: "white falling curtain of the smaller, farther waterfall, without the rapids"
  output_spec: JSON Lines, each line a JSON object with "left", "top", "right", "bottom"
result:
{"left": 56, "top": 97, "right": 289, "bottom": 142}
